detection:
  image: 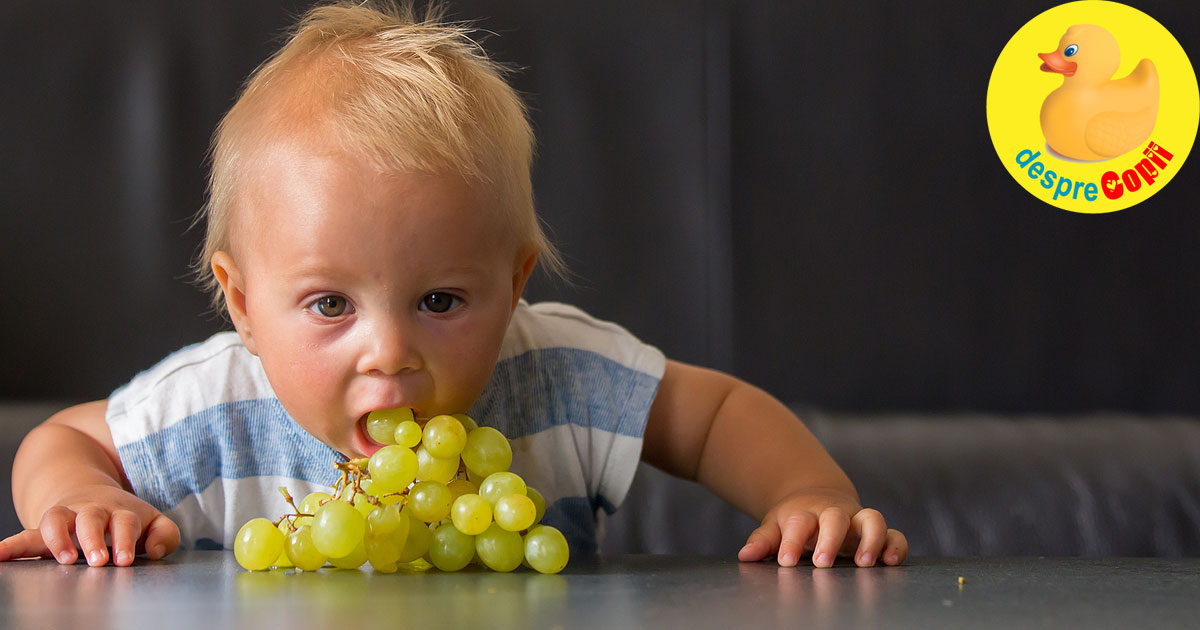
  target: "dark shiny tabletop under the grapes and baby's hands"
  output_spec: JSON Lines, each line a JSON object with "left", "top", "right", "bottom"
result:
{"left": 0, "top": 552, "right": 1200, "bottom": 630}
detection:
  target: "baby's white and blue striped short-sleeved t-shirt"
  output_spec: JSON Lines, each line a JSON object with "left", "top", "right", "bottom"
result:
{"left": 107, "top": 300, "right": 666, "bottom": 554}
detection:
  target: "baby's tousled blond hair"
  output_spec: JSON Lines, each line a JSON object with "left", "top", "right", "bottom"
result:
{"left": 193, "top": 1, "right": 566, "bottom": 310}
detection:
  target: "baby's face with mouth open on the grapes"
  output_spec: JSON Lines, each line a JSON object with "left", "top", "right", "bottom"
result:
{"left": 214, "top": 136, "right": 535, "bottom": 457}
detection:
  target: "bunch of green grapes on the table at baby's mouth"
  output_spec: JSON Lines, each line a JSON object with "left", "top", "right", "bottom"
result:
{"left": 233, "top": 408, "right": 569, "bottom": 574}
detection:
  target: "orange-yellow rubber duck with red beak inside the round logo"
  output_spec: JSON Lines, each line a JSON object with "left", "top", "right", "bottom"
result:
{"left": 1038, "top": 24, "right": 1158, "bottom": 161}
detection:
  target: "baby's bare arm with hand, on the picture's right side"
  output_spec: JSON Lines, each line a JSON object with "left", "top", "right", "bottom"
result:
{"left": 642, "top": 361, "right": 908, "bottom": 566}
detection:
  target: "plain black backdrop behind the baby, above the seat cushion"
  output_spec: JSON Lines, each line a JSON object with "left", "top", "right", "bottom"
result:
{"left": 0, "top": 0, "right": 1200, "bottom": 414}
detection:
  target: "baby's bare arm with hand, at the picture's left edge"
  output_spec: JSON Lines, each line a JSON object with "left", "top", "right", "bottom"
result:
{"left": 0, "top": 401, "right": 179, "bottom": 566}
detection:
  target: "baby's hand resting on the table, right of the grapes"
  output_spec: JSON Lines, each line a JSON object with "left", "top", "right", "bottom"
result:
{"left": 738, "top": 491, "right": 908, "bottom": 568}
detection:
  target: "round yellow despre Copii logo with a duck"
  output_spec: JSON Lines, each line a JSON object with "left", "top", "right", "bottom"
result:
{"left": 988, "top": 0, "right": 1200, "bottom": 214}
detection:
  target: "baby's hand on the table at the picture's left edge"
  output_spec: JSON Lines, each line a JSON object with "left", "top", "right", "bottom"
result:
{"left": 0, "top": 486, "right": 179, "bottom": 566}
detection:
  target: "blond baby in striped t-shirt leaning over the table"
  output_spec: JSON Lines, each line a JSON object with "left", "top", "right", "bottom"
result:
{"left": 0, "top": 2, "right": 908, "bottom": 566}
